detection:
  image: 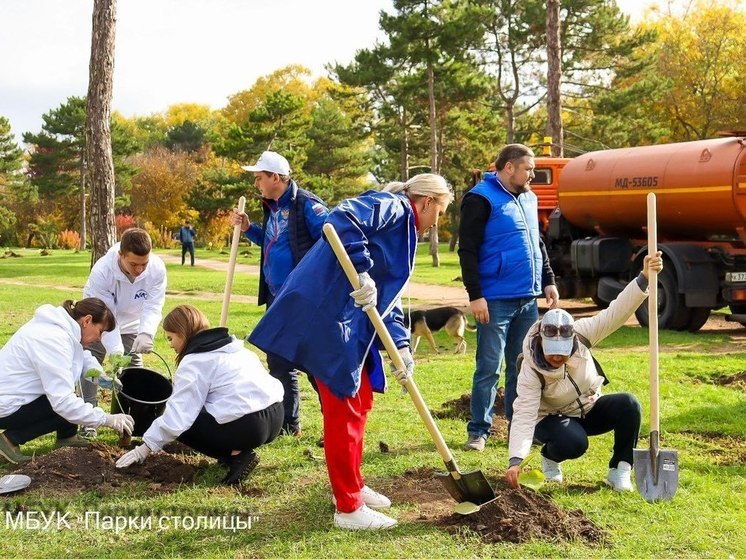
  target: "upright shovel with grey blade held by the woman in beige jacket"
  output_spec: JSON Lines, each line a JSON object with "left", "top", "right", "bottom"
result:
{"left": 633, "top": 192, "right": 679, "bottom": 502}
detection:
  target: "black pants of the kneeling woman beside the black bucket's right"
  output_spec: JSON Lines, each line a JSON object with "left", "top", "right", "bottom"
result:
{"left": 177, "top": 402, "right": 283, "bottom": 461}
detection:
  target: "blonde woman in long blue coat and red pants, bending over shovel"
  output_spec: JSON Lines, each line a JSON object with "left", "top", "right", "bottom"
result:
{"left": 249, "top": 173, "right": 453, "bottom": 529}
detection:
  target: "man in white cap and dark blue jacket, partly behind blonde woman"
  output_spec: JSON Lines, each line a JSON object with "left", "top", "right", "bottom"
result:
{"left": 232, "top": 151, "right": 329, "bottom": 436}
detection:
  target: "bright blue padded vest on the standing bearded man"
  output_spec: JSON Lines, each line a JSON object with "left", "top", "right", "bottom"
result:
{"left": 468, "top": 173, "right": 542, "bottom": 300}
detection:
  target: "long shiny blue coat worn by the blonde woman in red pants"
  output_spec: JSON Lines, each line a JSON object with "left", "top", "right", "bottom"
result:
{"left": 249, "top": 191, "right": 417, "bottom": 398}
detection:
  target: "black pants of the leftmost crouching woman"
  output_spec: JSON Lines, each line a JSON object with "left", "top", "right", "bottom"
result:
{"left": 0, "top": 395, "right": 78, "bottom": 445}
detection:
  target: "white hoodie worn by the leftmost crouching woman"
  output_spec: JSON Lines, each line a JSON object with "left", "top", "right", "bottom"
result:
{"left": 0, "top": 305, "right": 106, "bottom": 427}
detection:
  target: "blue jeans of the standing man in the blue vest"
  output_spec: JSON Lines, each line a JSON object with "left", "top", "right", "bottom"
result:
{"left": 466, "top": 297, "right": 539, "bottom": 438}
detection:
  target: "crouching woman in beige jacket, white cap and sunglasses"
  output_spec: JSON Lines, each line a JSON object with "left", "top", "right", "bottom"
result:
{"left": 505, "top": 252, "right": 663, "bottom": 491}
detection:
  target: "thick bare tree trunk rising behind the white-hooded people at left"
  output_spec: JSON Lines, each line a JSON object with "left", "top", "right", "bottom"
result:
{"left": 85, "top": 0, "right": 117, "bottom": 264}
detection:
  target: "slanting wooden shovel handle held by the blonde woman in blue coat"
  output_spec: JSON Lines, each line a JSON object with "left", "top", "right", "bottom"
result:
{"left": 324, "top": 223, "right": 461, "bottom": 479}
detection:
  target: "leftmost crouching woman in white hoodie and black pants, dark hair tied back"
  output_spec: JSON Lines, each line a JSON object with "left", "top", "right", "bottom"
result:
{"left": 0, "top": 297, "right": 134, "bottom": 464}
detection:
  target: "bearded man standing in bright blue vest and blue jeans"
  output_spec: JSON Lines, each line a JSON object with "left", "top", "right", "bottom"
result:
{"left": 458, "top": 144, "right": 559, "bottom": 452}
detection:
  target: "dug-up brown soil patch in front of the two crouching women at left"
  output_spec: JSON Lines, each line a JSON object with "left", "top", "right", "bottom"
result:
{"left": 13, "top": 443, "right": 208, "bottom": 494}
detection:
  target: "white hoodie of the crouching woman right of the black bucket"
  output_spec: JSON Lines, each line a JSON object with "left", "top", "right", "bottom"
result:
{"left": 143, "top": 339, "right": 284, "bottom": 451}
